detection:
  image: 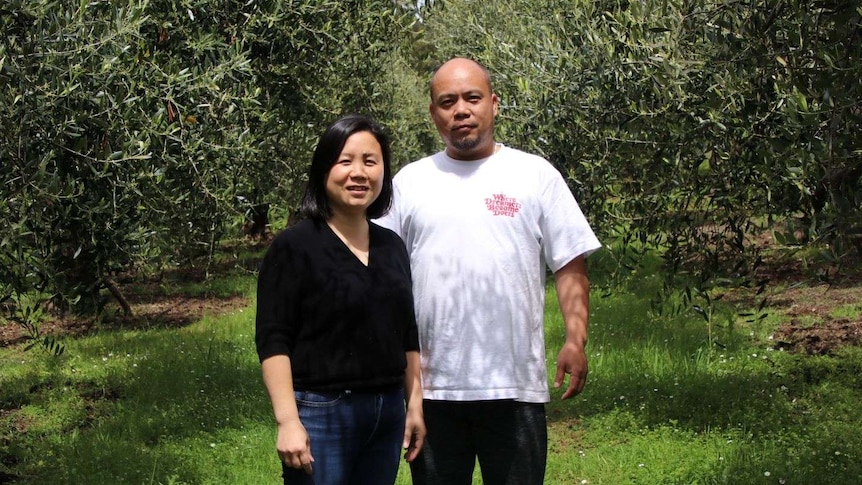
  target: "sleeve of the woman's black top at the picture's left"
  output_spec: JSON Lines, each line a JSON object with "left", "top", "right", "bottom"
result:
{"left": 255, "top": 233, "right": 301, "bottom": 362}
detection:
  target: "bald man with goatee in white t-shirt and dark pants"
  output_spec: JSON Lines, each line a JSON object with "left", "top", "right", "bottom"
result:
{"left": 380, "top": 58, "right": 601, "bottom": 485}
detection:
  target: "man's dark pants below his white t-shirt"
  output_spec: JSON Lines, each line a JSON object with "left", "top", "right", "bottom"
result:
{"left": 410, "top": 399, "right": 548, "bottom": 485}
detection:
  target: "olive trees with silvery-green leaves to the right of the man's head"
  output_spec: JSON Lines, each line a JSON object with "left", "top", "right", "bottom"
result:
{"left": 416, "top": 0, "right": 862, "bottom": 279}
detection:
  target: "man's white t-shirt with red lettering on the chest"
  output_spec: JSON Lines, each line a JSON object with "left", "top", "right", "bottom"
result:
{"left": 376, "top": 145, "right": 601, "bottom": 403}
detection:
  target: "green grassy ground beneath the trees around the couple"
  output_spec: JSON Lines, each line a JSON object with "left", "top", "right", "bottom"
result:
{"left": 0, "top": 244, "right": 862, "bottom": 485}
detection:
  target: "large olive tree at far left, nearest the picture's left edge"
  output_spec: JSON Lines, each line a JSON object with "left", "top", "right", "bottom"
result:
{"left": 0, "top": 1, "right": 264, "bottom": 312}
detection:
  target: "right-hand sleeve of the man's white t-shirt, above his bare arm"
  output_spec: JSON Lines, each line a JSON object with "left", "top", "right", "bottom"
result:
{"left": 540, "top": 164, "right": 602, "bottom": 272}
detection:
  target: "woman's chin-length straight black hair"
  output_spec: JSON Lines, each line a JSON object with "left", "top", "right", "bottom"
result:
{"left": 299, "top": 115, "right": 392, "bottom": 220}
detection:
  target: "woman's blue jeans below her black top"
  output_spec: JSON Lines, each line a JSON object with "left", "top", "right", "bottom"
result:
{"left": 281, "top": 389, "right": 405, "bottom": 485}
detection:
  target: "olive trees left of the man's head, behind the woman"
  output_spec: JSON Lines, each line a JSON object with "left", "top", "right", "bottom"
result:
{"left": 0, "top": 0, "right": 426, "bottom": 328}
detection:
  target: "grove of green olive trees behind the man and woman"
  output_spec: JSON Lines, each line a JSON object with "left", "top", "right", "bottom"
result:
{"left": 0, "top": 0, "right": 862, "bottom": 328}
